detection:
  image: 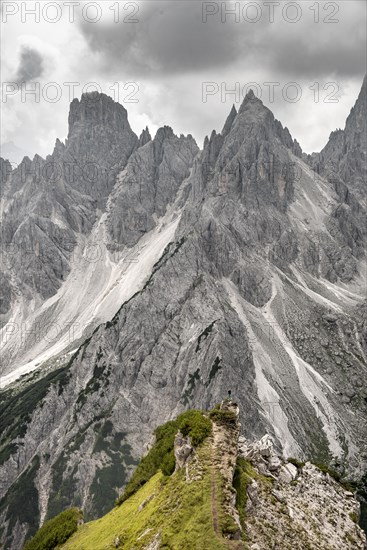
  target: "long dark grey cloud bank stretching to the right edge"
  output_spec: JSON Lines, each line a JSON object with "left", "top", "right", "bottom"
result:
{"left": 80, "top": 0, "right": 366, "bottom": 79}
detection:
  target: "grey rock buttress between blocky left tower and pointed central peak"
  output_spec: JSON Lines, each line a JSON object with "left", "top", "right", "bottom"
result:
{"left": 106, "top": 126, "right": 199, "bottom": 247}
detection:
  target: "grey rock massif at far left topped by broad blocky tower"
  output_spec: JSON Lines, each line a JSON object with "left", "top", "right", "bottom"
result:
{"left": 0, "top": 93, "right": 138, "bottom": 311}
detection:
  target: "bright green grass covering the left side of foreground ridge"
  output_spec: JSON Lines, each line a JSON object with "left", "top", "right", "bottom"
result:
{"left": 62, "top": 441, "right": 233, "bottom": 550}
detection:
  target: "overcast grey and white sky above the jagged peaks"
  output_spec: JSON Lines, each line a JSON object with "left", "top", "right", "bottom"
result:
{"left": 1, "top": 0, "right": 366, "bottom": 160}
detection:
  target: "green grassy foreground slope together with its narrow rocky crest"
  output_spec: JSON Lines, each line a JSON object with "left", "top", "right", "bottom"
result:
{"left": 65, "top": 406, "right": 244, "bottom": 550}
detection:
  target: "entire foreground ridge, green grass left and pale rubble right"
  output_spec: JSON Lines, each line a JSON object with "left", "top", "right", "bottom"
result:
{"left": 26, "top": 401, "right": 366, "bottom": 550}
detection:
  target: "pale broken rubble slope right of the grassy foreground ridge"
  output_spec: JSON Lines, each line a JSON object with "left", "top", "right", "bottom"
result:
{"left": 239, "top": 435, "right": 366, "bottom": 550}
